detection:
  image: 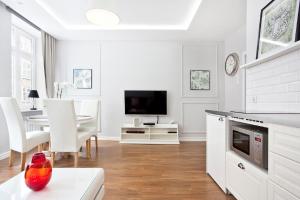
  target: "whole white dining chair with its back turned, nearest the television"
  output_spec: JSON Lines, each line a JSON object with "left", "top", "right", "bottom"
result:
{"left": 45, "top": 99, "right": 92, "bottom": 167}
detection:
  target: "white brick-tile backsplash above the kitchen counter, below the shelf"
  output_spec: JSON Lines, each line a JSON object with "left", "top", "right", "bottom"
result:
{"left": 246, "top": 50, "right": 300, "bottom": 113}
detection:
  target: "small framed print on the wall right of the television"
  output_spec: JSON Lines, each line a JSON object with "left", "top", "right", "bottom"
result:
{"left": 190, "top": 70, "right": 210, "bottom": 90}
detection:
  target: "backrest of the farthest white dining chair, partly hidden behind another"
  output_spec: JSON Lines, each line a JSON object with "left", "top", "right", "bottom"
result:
{"left": 79, "top": 99, "right": 100, "bottom": 131}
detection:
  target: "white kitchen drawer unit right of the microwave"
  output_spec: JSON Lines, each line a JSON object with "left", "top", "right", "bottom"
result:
{"left": 269, "top": 124, "right": 300, "bottom": 199}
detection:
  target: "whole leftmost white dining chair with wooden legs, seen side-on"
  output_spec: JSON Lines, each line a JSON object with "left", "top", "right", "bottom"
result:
{"left": 0, "top": 97, "right": 49, "bottom": 171}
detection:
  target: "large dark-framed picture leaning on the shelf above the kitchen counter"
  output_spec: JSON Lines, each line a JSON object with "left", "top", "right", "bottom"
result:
{"left": 256, "top": 0, "right": 300, "bottom": 58}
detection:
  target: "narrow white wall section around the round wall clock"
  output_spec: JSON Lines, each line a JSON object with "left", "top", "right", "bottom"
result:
{"left": 224, "top": 25, "right": 246, "bottom": 111}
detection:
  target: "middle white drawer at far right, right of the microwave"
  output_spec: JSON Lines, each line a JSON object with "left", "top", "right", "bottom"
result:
{"left": 269, "top": 153, "right": 300, "bottom": 198}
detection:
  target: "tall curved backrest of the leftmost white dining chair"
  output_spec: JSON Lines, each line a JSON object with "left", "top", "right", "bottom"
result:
{"left": 0, "top": 97, "right": 26, "bottom": 152}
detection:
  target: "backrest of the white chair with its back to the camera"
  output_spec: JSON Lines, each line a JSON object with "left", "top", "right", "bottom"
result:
{"left": 45, "top": 99, "right": 78, "bottom": 152}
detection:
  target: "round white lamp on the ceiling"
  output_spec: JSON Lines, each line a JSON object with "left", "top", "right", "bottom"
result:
{"left": 86, "top": 0, "right": 120, "bottom": 27}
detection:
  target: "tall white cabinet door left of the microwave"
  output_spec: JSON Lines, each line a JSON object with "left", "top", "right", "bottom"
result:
{"left": 206, "top": 114, "right": 228, "bottom": 192}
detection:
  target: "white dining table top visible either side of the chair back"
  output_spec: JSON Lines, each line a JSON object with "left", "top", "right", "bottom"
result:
{"left": 27, "top": 115, "right": 94, "bottom": 126}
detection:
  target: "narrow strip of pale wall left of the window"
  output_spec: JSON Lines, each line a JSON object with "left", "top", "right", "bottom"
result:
{"left": 0, "top": 2, "right": 12, "bottom": 158}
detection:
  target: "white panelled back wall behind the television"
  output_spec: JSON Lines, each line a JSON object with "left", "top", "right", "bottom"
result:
{"left": 57, "top": 41, "right": 224, "bottom": 139}
